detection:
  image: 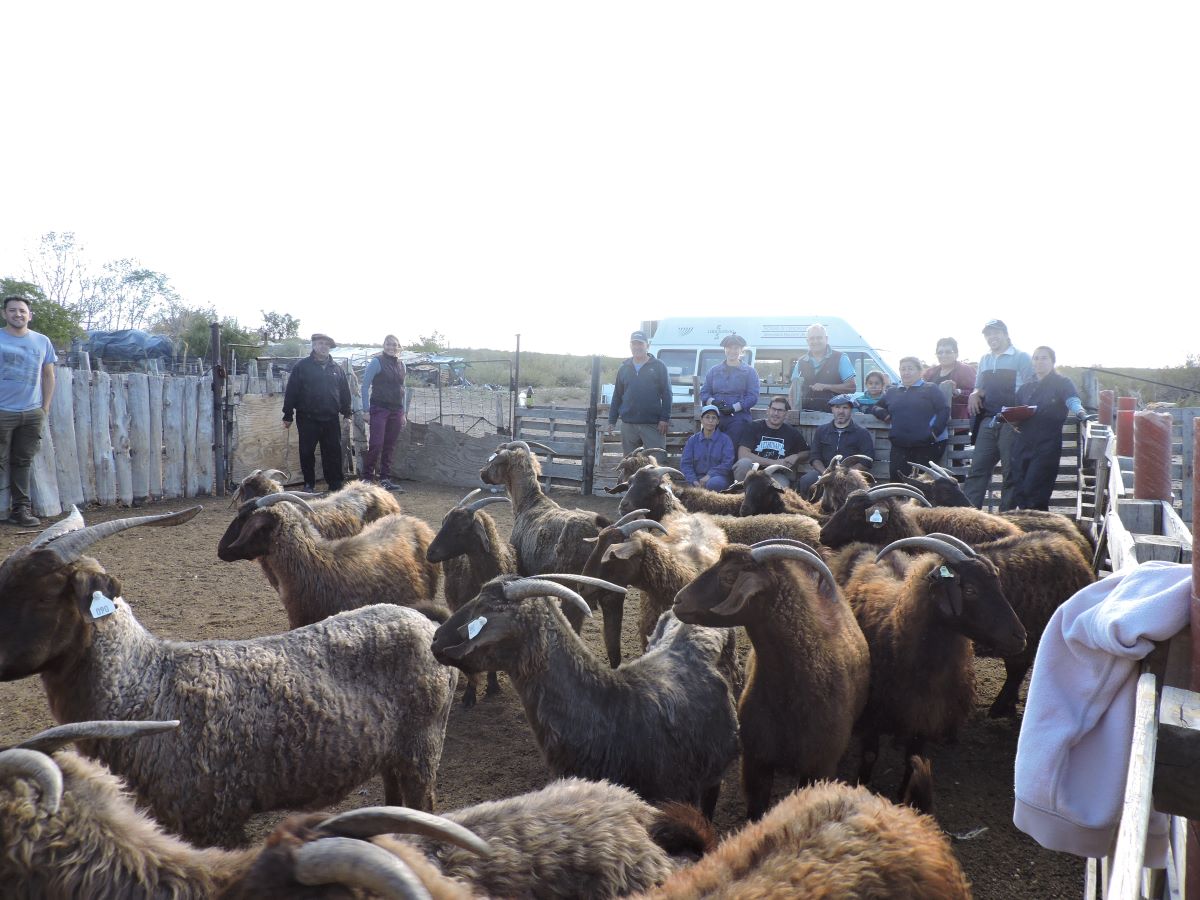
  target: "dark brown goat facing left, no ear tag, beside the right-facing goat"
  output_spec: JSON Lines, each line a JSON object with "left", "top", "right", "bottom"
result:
{"left": 674, "top": 542, "right": 870, "bottom": 818}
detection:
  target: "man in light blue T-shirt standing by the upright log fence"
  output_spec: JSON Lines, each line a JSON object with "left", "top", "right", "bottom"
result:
{"left": 0, "top": 296, "right": 58, "bottom": 528}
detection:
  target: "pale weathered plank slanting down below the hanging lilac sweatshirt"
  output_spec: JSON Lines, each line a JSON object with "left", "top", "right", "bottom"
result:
{"left": 1106, "top": 672, "right": 1158, "bottom": 900}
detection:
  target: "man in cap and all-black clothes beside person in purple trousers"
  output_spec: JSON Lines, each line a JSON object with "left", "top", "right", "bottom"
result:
{"left": 283, "top": 332, "right": 350, "bottom": 491}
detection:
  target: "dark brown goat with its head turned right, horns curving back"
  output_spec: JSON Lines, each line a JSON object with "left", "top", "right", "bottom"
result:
{"left": 845, "top": 535, "right": 1025, "bottom": 796}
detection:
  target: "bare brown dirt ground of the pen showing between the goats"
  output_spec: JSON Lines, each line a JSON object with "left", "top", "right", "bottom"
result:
{"left": 0, "top": 481, "right": 1082, "bottom": 899}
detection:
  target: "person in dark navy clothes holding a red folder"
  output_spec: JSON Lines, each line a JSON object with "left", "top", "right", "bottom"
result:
{"left": 1012, "top": 347, "right": 1087, "bottom": 510}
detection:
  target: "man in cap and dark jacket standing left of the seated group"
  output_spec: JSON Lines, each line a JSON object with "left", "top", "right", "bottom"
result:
{"left": 607, "top": 331, "right": 671, "bottom": 463}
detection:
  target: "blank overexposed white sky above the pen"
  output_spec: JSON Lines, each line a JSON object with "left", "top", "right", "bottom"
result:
{"left": 0, "top": 0, "right": 1200, "bottom": 366}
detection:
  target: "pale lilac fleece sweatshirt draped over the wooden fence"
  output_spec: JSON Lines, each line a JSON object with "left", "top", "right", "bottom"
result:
{"left": 1013, "top": 562, "right": 1192, "bottom": 869}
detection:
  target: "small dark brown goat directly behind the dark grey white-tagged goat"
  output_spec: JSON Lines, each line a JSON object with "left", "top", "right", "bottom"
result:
{"left": 425, "top": 487, "right": 517, "bottom": 708}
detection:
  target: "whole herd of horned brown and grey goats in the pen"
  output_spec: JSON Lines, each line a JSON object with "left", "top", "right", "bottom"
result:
{"left": 0, "top": 440, "right": 1092, "bottom": 898}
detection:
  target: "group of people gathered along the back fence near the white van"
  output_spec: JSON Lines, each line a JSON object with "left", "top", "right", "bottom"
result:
{"left": 608, "top": 319, "right": 1086, "bottom": 510}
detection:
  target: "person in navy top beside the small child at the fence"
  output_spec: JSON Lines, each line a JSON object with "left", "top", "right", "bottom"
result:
{"left": 871, "top": 356, "right": 950, "bottom": 484}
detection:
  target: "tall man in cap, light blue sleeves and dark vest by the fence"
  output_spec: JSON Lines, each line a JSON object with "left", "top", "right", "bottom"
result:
{"left": 962, "top": 319, "right": 1033, "bottom": 512}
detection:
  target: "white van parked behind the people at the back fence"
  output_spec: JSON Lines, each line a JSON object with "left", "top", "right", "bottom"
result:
{"left": 604, "top": 316, "right": 900, "bottom": 406}
